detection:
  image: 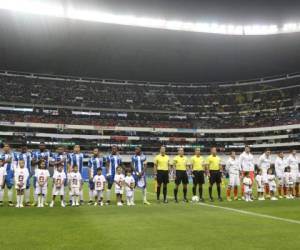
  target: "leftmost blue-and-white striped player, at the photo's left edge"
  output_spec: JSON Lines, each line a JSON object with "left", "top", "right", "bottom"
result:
{"left": 1, "top": 143, "right": 14, "bottom": 207}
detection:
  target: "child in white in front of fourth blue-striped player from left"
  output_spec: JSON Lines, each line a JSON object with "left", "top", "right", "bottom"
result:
{"left": 50, "top": 162, "right": 67, "bottom": 207}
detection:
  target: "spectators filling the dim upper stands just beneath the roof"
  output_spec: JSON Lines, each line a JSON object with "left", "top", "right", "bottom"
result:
{"left": 0, "top": 72, "right": 300, "bottom": 128}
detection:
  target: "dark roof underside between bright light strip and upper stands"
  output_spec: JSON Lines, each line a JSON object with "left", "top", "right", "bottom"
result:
{"left": 0, "top": 11, "right": 300, "bottom": 82}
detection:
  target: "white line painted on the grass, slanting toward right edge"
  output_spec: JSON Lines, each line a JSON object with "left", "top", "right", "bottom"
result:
{"left": 147, "top": 192, "right": 300, "bottom": 225}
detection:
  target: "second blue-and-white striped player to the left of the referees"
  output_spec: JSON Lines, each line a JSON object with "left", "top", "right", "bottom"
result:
{"left": 106, "top": 146, "right": 122, "bottom": 205}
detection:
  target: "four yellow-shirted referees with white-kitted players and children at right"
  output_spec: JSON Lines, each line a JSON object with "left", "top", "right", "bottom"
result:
{"left": 154, "top": 146, "right": 300, "bottom": 203}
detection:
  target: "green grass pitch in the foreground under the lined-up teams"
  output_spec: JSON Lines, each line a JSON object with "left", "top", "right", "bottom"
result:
{"left": 0, "top": 181, "right": 300, "bottom": 250}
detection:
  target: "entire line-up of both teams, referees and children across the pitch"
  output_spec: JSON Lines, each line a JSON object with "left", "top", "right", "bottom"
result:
{"left": 0, "top": 143, "right": 300, "bottom": 206}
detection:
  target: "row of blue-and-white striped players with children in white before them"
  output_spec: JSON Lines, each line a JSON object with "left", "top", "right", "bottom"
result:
{"left": 0, "top": 143, "right": 150, "bottom": 207}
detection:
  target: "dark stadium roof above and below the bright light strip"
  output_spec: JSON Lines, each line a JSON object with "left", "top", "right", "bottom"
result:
{"left": 0, "top": 0, "right": 300, "bottom": 82}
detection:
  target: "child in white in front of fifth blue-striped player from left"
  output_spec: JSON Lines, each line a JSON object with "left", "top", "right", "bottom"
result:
{"left": 68, "top": 164, "right": 82, "bottom": 207}
